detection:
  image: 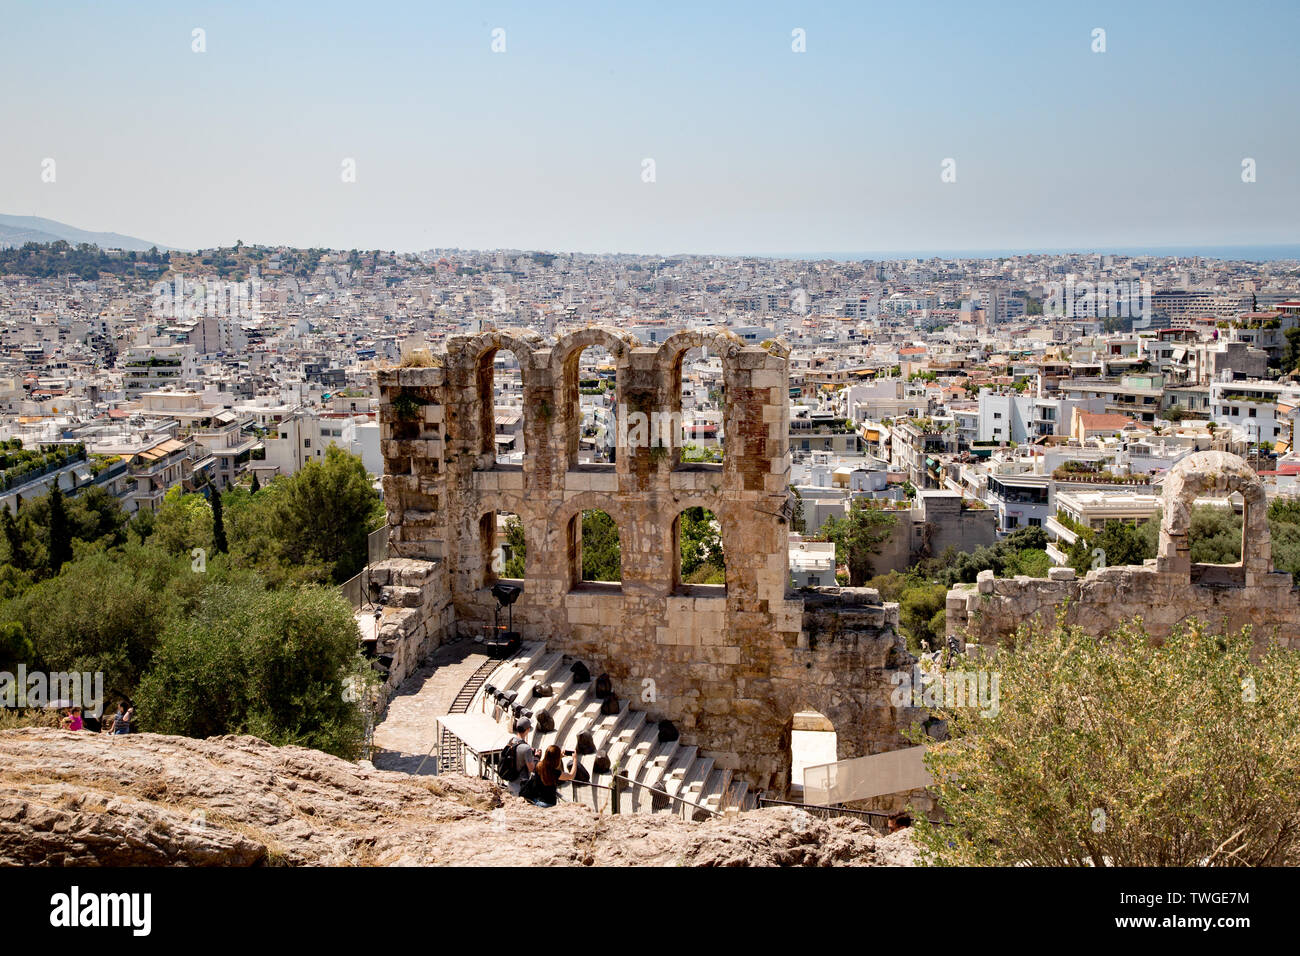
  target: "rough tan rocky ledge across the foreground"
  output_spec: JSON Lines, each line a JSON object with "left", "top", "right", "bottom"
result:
{"left": 0, "top": 728, "right": 917, "bottom": 866}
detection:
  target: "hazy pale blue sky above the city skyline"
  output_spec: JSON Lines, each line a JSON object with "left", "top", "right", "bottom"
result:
{"left": 0, "top": 0, "right": 1300, "bottom": 254}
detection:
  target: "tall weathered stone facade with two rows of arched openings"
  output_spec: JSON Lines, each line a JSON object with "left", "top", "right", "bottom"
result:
{"left": 378, "top": 328, "right": 914, "bottom": 791}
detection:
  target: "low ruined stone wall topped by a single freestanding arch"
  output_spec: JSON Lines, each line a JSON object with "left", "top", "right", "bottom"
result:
{"left": 948, "top": 451, "right": 1300, "bottom": 646}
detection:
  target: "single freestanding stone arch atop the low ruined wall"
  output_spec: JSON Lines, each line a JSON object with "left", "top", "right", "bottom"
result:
{"left": 1157, "top": 451, "right": 1273, "bottom": 584}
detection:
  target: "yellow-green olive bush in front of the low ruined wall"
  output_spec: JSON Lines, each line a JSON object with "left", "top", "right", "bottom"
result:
{"left": 915, "top": 620, "right": 1300, "bottom": 866}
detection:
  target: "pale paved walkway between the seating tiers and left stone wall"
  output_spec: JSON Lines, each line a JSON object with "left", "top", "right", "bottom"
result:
{"left": 371, "top": 637, "right": 488, "bottom": 774}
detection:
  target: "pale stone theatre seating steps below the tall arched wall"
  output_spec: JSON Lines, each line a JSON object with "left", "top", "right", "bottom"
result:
{"left": 469, "top": 641, "right": 755, "bottom": 819}
